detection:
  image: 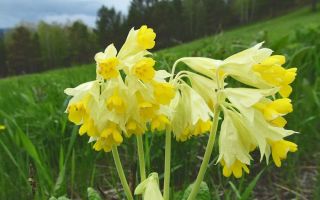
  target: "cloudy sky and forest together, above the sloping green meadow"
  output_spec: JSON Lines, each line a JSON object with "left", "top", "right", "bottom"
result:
{"left": 0, "top": 0, "right": 316, "bottom": 76}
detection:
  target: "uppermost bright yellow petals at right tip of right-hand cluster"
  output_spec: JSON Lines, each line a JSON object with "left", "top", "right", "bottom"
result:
{"left": 253, "top": 55, "right": 297, "bottom": 97}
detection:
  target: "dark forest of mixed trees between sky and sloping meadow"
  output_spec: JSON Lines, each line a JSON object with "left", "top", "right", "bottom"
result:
{"left": 0, "top": 0, "right": 316, "bottom": 77}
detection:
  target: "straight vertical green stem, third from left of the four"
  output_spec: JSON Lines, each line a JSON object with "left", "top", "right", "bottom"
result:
{"left": 163, "top": 128, "right": 171, "bottom": 200}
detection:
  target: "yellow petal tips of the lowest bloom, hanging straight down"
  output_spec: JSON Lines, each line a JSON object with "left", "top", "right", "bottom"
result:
{"left": 220, "top": 160, "right": 250, "bottom": 178}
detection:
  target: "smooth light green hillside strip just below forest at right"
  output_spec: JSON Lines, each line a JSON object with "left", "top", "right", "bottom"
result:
{"left": 159, "top": 8, "right": 320, "bottom": 57}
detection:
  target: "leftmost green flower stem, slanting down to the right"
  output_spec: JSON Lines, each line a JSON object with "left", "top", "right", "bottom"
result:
{"left": 112, "top": 145, "right": 133, "bottom": 200}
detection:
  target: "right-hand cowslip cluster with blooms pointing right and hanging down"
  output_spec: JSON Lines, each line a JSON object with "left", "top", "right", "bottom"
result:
{"left": 175, "top": 44, "right": 297, "bottom": 178}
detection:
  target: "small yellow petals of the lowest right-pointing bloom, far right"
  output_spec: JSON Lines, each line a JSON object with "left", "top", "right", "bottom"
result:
{"left": 269, "top": 140, "right": 298, "bottom": 167}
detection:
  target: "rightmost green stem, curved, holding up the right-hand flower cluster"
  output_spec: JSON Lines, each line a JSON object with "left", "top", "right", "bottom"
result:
{"left": 188, "top": 106, "right": 220, "bottom": 200}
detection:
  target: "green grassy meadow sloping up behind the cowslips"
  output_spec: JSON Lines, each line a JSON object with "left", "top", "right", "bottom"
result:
{"left": 0, "top": 9, "right": 320, "bottom": 199}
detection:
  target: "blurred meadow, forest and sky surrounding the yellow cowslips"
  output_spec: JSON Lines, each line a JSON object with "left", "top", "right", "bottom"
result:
{"left": 0, "top": 0, "right": 320, "bottom": 200}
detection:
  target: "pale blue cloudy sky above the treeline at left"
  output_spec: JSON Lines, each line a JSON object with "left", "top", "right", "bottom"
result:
{"left": 0, "top": 0, "right": 130, "bottom": 28}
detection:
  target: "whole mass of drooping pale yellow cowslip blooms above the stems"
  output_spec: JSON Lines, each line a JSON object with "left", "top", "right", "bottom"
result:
{"left": 65, "top": 25, "right": 297, "bottom": 181}
